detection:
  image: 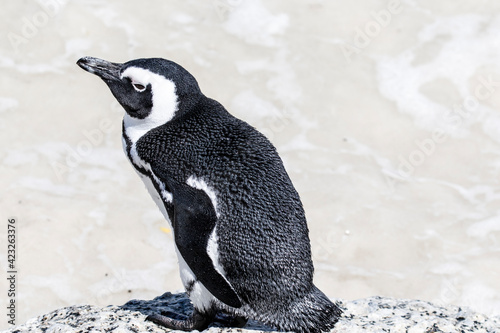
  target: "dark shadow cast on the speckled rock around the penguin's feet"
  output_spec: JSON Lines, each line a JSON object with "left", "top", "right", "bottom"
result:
{"left": 120, "top": 292, "right": 276, "bottom": 332}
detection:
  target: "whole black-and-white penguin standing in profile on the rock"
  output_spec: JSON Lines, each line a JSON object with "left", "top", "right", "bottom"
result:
{"left": 78, "top": 57, "right": 341, "bottom": 332}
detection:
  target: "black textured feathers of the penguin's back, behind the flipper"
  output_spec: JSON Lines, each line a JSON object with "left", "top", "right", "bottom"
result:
{"left": 137, "top": 96, "right": 336, "bottom": 331}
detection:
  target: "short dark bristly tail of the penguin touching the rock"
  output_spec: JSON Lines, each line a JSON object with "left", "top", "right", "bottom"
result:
{"left": 280, "top": 285, "right": 342, "bottom": 333}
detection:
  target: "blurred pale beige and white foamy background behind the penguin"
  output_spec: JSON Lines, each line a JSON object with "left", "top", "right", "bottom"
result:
{"left": 0, "top": 0, "right": 500, "bottom": 328}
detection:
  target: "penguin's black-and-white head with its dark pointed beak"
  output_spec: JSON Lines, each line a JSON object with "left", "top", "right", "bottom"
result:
{"left": 77, "top": 57, "right": 202, "bottom": 125}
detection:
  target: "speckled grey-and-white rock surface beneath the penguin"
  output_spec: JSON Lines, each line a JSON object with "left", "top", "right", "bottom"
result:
{"left": 5, "top": 293, "right": 500, "bottom": 333}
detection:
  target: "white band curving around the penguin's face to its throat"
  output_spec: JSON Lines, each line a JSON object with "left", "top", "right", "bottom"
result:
{"left": 120, "top": 66, "right": 179, "bottom": 144}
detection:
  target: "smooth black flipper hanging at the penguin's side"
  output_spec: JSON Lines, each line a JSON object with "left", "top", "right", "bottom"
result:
{"left": 151, "top": 165, "right": 241, "bottom": 308}
